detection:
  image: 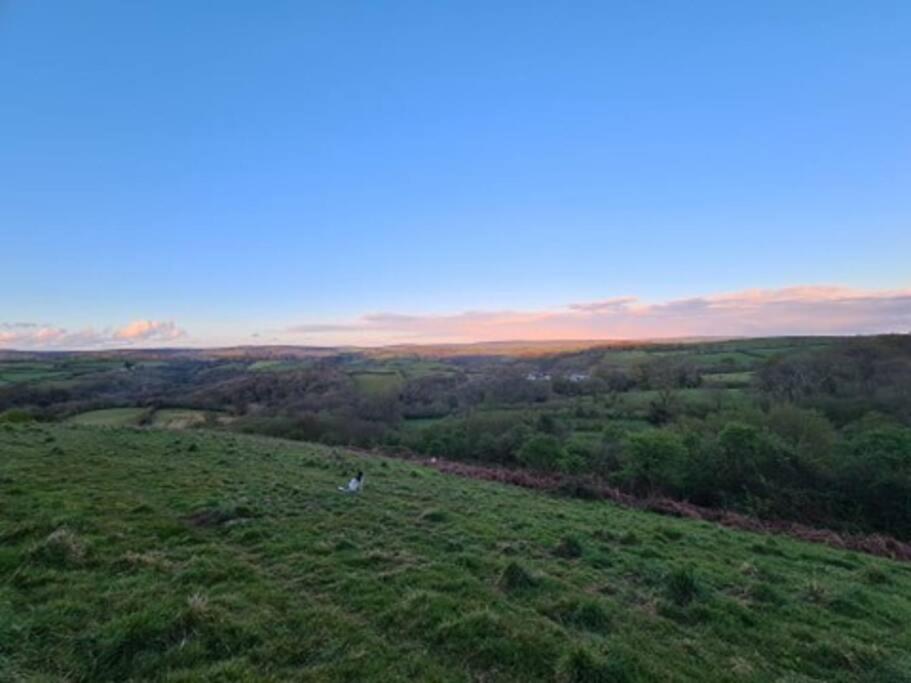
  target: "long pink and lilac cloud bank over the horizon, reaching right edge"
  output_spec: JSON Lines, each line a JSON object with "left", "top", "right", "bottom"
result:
{"left": 284, "top": 286, "right": 911, "bottom": 344}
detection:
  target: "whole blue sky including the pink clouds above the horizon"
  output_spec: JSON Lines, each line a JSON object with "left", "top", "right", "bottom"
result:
{"left": 0, "top": 0, "right": 911, "bottom": 349}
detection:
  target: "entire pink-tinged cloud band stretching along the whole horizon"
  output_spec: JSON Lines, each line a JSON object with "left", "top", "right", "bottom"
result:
{"left": 0, "top": 286, "right": 911, "bottom": 350}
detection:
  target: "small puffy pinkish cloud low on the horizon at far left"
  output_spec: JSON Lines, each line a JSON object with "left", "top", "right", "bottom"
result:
{"left": 0, "top": 320, "right": 186, "bottom": 350}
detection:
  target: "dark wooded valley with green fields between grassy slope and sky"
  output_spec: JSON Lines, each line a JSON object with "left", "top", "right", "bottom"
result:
{"left": 0, "top": 335, "right": 911, "bottom": 539}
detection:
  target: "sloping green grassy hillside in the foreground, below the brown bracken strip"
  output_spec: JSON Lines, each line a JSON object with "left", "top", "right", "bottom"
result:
{"left": 0, "top": 425, "right": 911, "bottom": 682}
